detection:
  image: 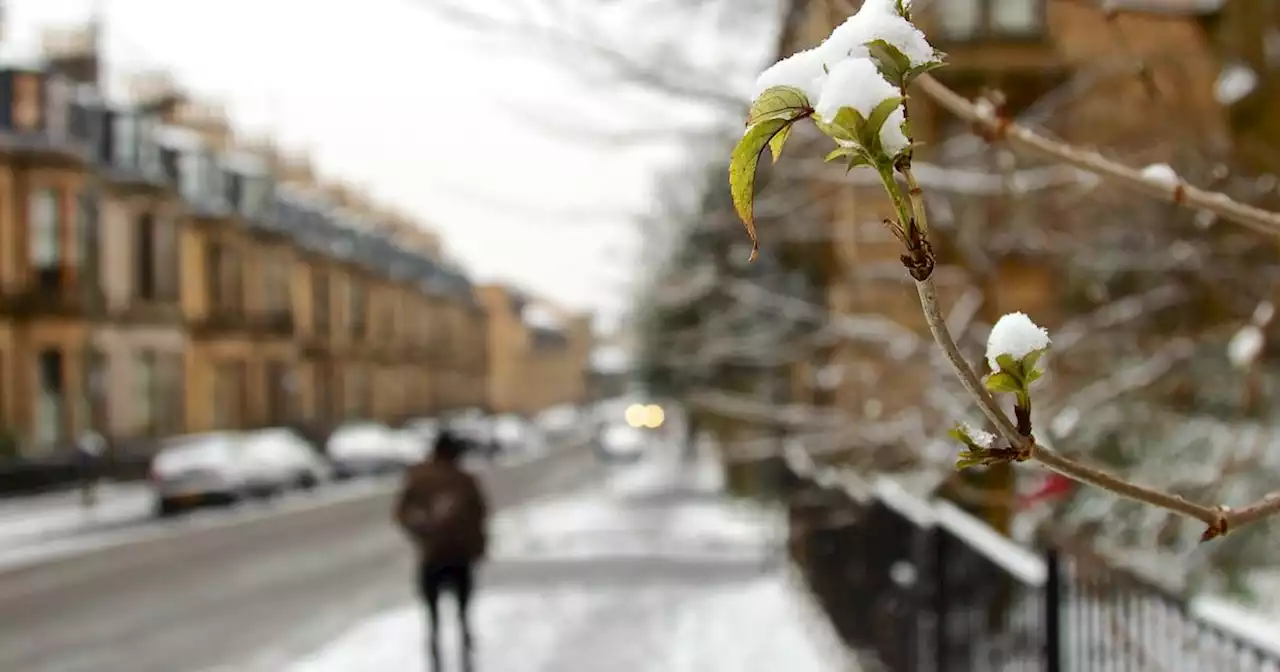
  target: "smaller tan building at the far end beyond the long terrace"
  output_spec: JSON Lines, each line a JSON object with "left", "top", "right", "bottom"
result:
{"left": 480, "top": 284, "right": 594, "bottom": 415}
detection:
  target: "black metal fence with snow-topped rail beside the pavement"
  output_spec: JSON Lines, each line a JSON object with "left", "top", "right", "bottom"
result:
{"left": 788, "top": 468, "right": 1280, "bottom": 672}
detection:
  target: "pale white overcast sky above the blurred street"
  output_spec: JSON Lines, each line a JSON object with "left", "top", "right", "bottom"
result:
{"left": 4, "top": 0, "right": 768, "bottom": 330}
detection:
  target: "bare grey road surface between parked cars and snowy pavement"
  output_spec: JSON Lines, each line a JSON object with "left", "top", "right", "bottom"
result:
{"left": 0, "top": 440, "right": 596, "bottom": 672}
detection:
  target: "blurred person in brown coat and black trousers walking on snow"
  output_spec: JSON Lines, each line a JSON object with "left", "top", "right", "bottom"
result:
{"left": 394, "top": 430, "right": 489, "bottom": 672}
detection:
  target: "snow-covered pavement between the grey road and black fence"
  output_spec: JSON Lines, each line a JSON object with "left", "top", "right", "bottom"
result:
{"left": 288, "top": 442, "right": 854, "bottom": 672}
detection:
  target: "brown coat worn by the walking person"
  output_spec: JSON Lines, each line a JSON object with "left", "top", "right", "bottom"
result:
{"left": 396, "top": 461, "right": 489, "bottom": 564}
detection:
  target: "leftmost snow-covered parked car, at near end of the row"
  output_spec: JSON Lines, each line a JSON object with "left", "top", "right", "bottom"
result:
{"left": 150, "top": 433, "right": 246, "bottom": 516}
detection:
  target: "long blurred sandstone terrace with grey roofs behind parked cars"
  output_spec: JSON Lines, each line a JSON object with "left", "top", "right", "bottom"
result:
{"left": 0, "top": 22, "right": 491, "bottom": 456}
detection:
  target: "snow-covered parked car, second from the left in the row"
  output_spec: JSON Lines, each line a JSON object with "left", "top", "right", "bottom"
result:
{"left": 237, "top": 428, "right": 333, "bottom": 497}
